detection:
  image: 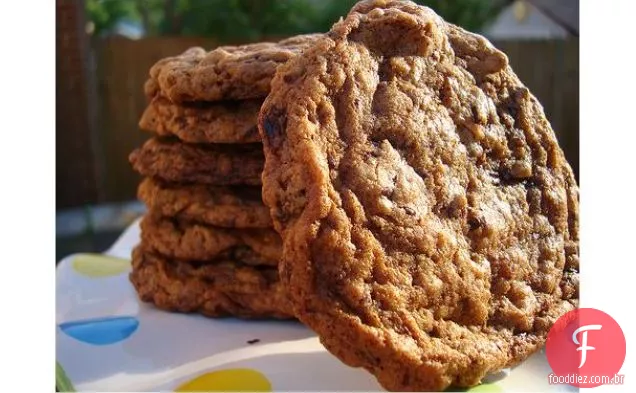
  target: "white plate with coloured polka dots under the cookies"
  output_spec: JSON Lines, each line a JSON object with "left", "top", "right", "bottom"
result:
{"left": 56, "top": 222, "right": 577, "bottom": 392}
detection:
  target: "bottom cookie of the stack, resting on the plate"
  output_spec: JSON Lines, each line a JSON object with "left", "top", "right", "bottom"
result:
{"left": 130, "top": 246, "right": 292, "bottom": 319}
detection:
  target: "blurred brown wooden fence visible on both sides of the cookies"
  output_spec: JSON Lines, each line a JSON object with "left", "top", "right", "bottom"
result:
{"left": 66, "top": 37, "right": 579, "bottom": 202}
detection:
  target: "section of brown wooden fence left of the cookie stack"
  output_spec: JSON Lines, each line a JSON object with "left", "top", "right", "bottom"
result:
{"left": 93, "top": 37, "right": 224, "bottom": 201}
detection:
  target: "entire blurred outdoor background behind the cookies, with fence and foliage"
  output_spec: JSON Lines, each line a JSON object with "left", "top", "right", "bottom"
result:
{"left": 56, "top": 0, "right": 579, "bottom": 260}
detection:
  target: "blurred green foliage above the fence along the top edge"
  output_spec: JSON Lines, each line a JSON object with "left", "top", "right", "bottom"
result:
{"left": 85, "top": 0, "right": 506, "bottom": 41}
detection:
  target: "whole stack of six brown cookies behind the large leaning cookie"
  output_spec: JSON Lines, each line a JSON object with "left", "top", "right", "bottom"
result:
{"left": 130, "top": 36, "right": 316, "bottom": 318}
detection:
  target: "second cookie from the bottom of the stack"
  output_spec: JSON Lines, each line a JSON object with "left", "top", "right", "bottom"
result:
{"left": 141, "top": 212, "right": 282, "bottom": 266}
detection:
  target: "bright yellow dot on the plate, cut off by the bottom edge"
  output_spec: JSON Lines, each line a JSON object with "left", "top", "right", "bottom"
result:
{"left": 175, "top": 368, "right": 272, "bottom": 392}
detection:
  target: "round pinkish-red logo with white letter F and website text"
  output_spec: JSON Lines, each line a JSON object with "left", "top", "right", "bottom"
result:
{"left": 546, "top": 308, "right": 626, "bottom": 388}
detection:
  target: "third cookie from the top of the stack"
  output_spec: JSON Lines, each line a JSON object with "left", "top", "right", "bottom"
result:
{"left": 129, "top": 138, "right": 264, "bottom": 186}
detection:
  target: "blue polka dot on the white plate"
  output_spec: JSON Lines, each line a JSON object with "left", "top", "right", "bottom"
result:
{"left": 59, "top": 317, "right": 139, "bottom": 345}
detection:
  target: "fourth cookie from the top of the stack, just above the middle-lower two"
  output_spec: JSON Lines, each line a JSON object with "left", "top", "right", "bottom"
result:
{"left": 137, "top": 178, "right": 272, "bottom": 228}
